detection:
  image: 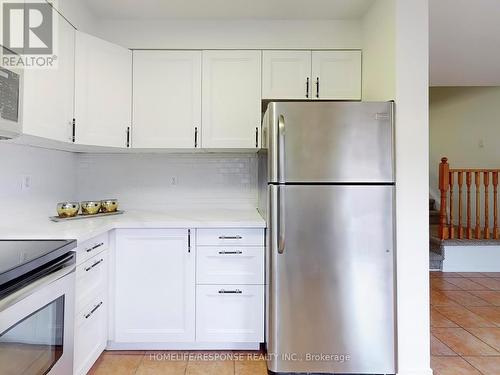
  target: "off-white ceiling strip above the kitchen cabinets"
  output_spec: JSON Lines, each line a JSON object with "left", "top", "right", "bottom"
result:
{"left": 84, "top": 0, "right": 374, "bottom": 19}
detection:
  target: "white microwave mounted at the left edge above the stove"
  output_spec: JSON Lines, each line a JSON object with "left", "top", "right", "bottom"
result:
{"left": 0, "top": 66, "right": 23, "bottom": 139}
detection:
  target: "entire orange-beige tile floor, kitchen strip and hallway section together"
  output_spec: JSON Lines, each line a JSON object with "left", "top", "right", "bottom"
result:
{"left": 90, "top": 272, "right": 500, "bottom": 375}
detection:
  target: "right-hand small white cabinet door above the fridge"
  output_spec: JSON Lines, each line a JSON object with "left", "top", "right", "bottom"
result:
{"left": 312, "top": 51, "right": 361, "bottom": 100}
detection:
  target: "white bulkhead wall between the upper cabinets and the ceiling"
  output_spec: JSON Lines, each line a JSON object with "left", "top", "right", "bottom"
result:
{"left": 94, "top": 19, "right": 361, "bottom": 49}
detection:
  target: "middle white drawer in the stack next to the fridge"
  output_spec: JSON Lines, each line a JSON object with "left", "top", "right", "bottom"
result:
{"left": 196, "top": 246, "right": 264, "bottom": 284}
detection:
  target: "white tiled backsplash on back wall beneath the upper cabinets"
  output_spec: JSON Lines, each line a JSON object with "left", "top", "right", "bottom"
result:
{"left": 77, "top": 154, "right": 257, "bottom": 210}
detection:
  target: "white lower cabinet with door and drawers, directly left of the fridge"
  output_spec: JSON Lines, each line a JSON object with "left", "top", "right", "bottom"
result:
{"left": 110, "top": 228, "right": 265, "bottom": 350}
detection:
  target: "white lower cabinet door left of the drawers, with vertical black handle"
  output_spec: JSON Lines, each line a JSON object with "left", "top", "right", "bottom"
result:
{"left": 114, "top": 229, "right": 195, "bottom": 343}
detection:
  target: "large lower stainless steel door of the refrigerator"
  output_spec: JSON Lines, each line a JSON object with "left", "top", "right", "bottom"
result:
{"left": 268, "top": 185, "right": 396, "bottom": 374}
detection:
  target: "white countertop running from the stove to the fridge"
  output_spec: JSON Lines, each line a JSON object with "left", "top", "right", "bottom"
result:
{"left": 0, "top": 209, "right": 266, "bottom": 242}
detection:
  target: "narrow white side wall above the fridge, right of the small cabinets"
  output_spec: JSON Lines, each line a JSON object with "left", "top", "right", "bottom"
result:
{"left": 362, "top": 0, "right": 396, "bottom": 101}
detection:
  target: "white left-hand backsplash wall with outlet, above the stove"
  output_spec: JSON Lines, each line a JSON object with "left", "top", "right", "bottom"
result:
{"left": 0, "top": 141, "right": 76, "bottom": 225}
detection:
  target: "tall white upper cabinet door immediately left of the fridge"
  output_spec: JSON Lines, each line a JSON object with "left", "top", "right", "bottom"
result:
{"left": 202, "top": 51, "right": 261, "bottom": 148}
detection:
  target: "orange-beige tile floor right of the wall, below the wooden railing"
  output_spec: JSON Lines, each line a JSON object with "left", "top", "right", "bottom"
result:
{"left": 430, "top": 272, "right": 500, "bottom": 375}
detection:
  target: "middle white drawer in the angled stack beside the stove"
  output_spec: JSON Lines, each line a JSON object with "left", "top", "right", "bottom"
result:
{"left": 75, "top": 251, "right": 108, "bottom": 311}
